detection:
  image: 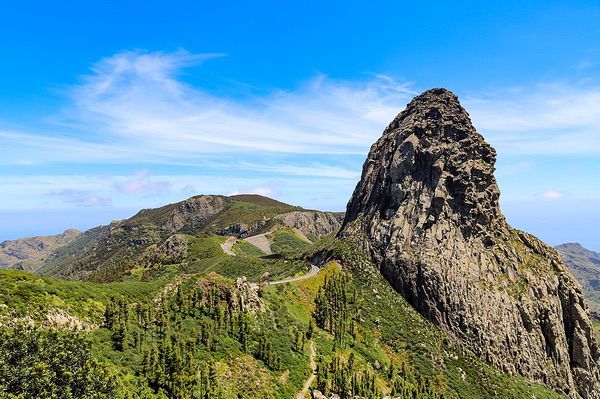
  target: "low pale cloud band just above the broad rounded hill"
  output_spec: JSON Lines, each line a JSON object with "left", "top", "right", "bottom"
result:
{"left": 0, "top": 174, "right": 355, "bottom": 210}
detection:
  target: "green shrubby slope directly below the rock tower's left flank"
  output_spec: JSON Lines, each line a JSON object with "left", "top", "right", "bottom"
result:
{"left": 308, "top": 240, "right": 562, "bottom": 398}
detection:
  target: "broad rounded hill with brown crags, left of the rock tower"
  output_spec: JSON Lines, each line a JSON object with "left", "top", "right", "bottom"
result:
{"left": 39, "top": 195, "right": 340, "bottom": 282}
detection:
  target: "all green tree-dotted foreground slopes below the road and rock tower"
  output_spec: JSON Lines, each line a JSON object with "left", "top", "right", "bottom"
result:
{"left": 0, "top": 238, "right": 561, "bottom": 399}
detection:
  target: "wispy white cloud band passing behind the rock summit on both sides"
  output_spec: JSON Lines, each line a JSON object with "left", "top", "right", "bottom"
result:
{"left": 0, "top": 51, "right": 600, "bottom": 170}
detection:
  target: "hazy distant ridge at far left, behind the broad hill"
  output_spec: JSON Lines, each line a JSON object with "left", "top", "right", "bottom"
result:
{"left": 0, "top": 229, "right": 81, "bottom": 271}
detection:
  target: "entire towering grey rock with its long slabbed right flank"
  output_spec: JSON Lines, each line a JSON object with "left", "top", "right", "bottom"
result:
{"left": 340, "top": 89, "right": 600, "bottom": 398}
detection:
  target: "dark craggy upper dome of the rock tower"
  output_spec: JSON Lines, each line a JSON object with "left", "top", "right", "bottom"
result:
{"left": 346, "top": 89, "right": 505, "bottom": 244}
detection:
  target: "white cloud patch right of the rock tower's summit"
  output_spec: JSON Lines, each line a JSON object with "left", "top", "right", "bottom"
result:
{"left": 463, "top": 82, "right": 600, "bottom": 155}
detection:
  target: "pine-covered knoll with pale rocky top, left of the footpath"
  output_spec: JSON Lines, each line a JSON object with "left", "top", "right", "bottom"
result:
{"left": 94, "top": 275, "right": 307, "bottom": 399}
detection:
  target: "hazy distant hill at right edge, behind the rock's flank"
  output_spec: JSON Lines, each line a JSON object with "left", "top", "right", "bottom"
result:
{"left": 556, "top": 243, "right": 600, "bottom": 320}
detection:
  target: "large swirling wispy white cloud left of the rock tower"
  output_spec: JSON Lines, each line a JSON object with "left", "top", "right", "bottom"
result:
{"left": 0, "top": 52, "right": 415, "bottom": 167}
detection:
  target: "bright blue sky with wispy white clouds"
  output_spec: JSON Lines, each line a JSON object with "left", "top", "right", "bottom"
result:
{"left": 0, "top": 0, "right": 600, "bottom": 251}
